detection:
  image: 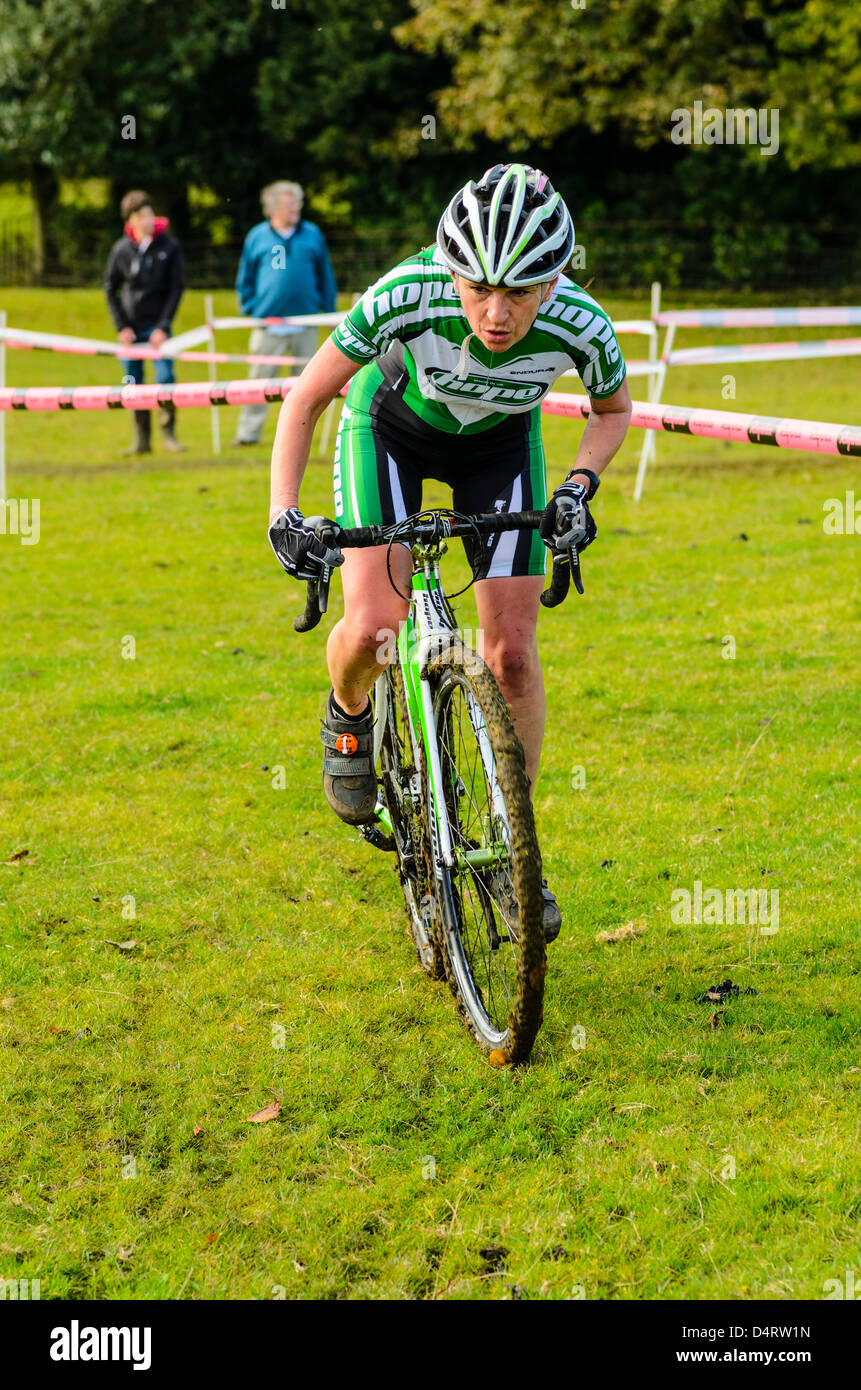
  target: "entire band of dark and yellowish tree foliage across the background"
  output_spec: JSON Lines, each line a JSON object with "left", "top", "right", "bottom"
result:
{"left": 0, "top": 0, "right": 861, "bottom": 287}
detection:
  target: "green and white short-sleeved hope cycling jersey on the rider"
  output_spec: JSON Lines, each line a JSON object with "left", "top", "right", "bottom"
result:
{"left": 332, "top": 246, "right": 626, "bottom": 435}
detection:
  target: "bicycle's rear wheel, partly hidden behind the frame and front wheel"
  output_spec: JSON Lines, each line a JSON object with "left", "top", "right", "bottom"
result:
{"left": 380, "top": 660, "right": 445, "bottom": 980}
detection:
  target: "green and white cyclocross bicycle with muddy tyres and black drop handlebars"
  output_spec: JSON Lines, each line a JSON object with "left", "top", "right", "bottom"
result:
{"left": 293, "top": 509, "right": 583, "bottom": 1065}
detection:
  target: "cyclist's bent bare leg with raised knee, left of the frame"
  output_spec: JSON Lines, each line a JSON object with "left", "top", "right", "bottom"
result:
{"left": 325, "top": 545, "right": 412, "bottom": 714}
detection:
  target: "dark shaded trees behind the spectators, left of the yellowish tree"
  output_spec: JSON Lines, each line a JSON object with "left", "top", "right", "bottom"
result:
{"left": 0, "top": 0, "right": 459, "bottom": 273}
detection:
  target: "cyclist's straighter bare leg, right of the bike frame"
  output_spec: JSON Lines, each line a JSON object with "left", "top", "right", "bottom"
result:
{"left": 476, "top": 574, "right": 547, "bottom": 788}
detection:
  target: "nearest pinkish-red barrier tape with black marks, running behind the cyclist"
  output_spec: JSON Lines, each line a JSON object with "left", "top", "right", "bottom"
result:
{"left": 0, "top": 378, "right": 861, "bottom": 457}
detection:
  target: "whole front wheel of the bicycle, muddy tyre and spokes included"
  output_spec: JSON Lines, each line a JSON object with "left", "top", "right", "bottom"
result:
{"left": 428, "top": 642, "right": 547, "bottom": 1063}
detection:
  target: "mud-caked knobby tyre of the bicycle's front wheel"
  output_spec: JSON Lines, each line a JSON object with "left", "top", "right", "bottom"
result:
{"left": 428, "top": 641, "right": 547, "bottom": 1063}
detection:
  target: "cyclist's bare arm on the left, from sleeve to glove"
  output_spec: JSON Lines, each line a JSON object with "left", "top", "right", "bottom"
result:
{"left": 268, "top": 338, "right": 360, "bottom": 521}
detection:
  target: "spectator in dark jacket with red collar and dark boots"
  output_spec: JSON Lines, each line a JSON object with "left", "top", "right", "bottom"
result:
{"left": 104, "top": 189, "right": 185, "bottom": 453}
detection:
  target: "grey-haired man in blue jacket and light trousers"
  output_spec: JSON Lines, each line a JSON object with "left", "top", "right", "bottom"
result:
{"left": 232, "top": 179, "right": 335, "bottom": 445}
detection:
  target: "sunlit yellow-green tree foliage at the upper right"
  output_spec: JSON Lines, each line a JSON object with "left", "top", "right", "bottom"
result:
{"left": 395, "top": 0, "right": 861, "bottom": 170}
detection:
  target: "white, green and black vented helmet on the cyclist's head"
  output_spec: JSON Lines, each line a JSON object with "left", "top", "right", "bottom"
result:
{"left": 437, "top": 164, "right": 574, "bottom": 289}
